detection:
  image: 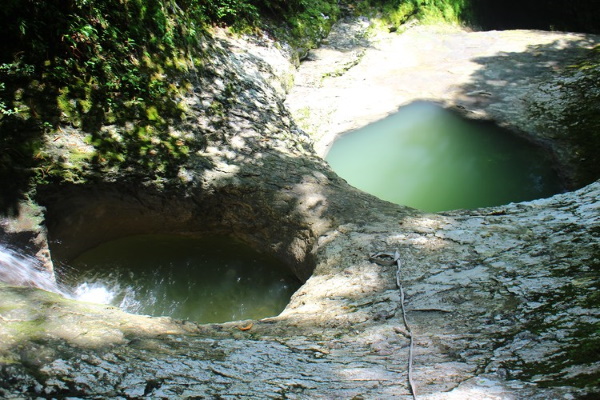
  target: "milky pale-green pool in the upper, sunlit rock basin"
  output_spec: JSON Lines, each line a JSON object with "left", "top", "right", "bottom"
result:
{"left": 326, "top": 103, "right": 562, "bottom": 212}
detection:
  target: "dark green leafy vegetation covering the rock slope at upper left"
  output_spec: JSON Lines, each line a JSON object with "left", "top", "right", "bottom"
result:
{"left": 0, "top": 0, "right": 337, "bottom": 216}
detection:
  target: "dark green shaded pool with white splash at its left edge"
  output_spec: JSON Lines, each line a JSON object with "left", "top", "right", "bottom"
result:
{"left": 58, "top": 235, "right": 300, "bottom": 323}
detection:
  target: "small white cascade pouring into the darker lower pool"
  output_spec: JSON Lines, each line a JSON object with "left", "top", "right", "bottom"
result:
{"left": 0, "top": 244, "right": 70, "bottom": 297}
